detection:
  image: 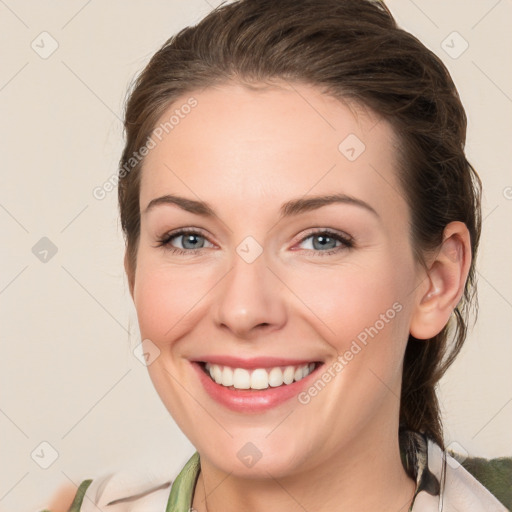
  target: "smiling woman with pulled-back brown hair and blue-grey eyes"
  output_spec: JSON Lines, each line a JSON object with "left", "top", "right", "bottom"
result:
{"left": 43, "top": 0, "right": 505, "bottom": 512}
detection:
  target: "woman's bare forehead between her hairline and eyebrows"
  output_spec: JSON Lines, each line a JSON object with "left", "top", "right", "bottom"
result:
{"left": 140, "top": 83, "right": 405, "bottom": 221}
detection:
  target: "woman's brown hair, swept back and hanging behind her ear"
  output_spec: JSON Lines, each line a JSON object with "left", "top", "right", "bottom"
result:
{"left": 118, "top": 0, "right": 481, "bottom": 448}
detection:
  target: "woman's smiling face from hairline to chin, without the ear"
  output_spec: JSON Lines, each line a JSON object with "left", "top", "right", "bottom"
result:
{"left": 133, "top": 84, "right": 423, "bottom": 477}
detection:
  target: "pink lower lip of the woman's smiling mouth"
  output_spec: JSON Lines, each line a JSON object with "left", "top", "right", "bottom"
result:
{"left": 192, "top": 362, "right": 319, "bottom": 413}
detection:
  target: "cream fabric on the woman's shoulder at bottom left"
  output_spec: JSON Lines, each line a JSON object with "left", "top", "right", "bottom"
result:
{"left": 63, "top": 469, "right": 172, "bottom": 512}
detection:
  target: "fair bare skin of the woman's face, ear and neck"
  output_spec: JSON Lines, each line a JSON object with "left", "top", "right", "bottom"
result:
{"left": 49, "top": 82, "right": 471, "bottom": 512}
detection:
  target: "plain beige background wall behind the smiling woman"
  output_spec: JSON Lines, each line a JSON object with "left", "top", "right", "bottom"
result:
{"left": 0, "top": 0, "right": 512, "bottom": 512}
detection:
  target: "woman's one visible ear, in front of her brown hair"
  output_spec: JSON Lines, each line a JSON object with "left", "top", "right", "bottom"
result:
{"left": 410, "top": 221, "right": 472, "bottom": 339}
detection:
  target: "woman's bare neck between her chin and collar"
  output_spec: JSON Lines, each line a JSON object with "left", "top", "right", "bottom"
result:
{"left": 193, "top": 420, "right": 416, "bottom": 512}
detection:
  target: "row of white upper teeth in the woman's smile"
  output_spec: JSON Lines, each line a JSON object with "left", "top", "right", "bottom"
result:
{"left": 200, "top": 362, "right": 321, "bottom": 390}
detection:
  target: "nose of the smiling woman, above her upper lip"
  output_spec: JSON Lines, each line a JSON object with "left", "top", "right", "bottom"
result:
{"left": 213, "top": 247, "right": 287, "bottom": 340}
